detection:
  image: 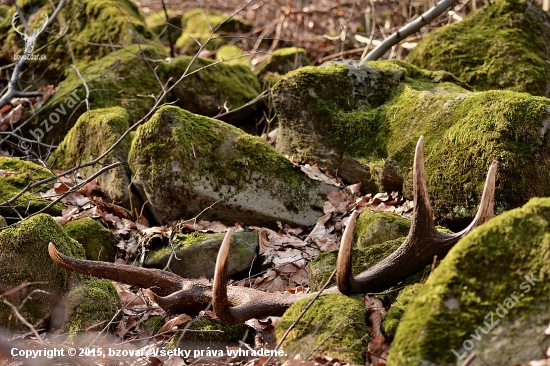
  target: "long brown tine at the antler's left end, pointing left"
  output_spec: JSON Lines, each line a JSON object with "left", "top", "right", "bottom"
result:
{"left": 48, "top": 243, "right": 182, "bottom": 296}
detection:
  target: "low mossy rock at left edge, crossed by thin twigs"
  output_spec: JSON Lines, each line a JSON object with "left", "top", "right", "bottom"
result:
{"left": 0, "top": 157, "right": 65, "bottom": 222}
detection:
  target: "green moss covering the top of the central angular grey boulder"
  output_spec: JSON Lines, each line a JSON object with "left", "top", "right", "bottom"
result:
{"left": 129, "top": 106, "right": 324, "bottom": 224}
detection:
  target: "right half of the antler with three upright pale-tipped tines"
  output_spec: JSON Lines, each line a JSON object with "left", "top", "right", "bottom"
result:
{"left": 337, "top": 136, "right": 498, "bottom": 295}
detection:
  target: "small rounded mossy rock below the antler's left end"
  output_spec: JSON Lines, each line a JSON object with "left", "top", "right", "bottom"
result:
{"left": 65, "top": 279, "right": 122, "bottom": 334}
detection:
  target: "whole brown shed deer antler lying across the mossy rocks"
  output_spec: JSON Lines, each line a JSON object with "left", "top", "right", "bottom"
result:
{"left": 48, "top": 137, "right": 497, "bottom": 324}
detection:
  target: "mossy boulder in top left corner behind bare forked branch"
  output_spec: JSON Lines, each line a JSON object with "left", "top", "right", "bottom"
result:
{"left": 0, "top": 0, "right": 153, "bottom": 85}
